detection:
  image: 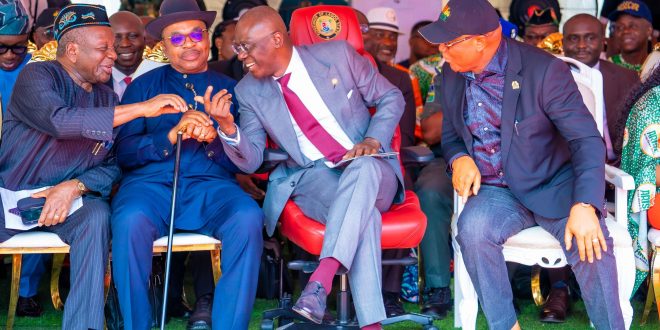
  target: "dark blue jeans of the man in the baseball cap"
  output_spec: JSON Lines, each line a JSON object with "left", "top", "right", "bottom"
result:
{"left": 456, "top": 186, "right": 625, "bottom": 330}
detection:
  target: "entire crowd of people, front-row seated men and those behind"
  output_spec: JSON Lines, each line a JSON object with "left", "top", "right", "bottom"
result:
{"left": 0, "top": 0, "right": 660, "bottom": 329}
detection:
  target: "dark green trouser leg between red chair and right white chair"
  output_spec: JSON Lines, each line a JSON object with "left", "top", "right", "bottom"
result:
{"left": 415, "top": 158, "right": 454, "bottom": 288}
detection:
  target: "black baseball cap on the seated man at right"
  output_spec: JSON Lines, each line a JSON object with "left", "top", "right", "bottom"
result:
{"left": 419, "top": 0, "right": 500, "bottom": 44}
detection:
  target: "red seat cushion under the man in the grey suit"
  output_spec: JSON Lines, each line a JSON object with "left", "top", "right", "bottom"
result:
{"left": 280, "top": 191, "right": 426, "bottom": 255}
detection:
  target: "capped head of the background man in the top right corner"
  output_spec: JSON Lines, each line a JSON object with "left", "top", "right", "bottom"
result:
{"left": 609, "top": 0, "right": 653, "bottom": 72}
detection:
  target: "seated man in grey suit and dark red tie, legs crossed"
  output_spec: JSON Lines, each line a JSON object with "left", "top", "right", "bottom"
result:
{"left": 204, "top": 7, "right": 405, "bottom": 328}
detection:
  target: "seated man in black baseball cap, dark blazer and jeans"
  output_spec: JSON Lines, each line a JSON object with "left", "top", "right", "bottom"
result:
{"left": 420, "top": 0, "right": 632, "bottom": 329}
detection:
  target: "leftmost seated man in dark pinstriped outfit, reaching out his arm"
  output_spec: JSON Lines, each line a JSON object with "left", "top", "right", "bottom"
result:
{"left": 0, "top": 5, "right": 186, "bottom": 330}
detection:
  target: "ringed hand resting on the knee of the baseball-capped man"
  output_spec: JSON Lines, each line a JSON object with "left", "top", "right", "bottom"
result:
{"left": 564, "top": 204, "right": 607, "bottom": 263}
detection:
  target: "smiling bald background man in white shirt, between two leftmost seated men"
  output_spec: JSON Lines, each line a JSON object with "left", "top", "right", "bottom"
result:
{"left": 108, "top": 11, "right": 145, "bottom": 99}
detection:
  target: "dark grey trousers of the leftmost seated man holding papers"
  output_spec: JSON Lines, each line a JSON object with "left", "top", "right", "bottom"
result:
{"left": 0, "top": 197, "right": 110, "bottom": 330}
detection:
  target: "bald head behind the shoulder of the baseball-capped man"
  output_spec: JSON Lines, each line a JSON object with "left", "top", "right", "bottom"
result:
{"left": 562, "top": 14, "right": 605, "bottom": 67}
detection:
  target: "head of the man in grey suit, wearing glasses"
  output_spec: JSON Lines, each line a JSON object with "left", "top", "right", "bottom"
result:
{"left": 234, "top": 6, "right": 293, "bottom": 79}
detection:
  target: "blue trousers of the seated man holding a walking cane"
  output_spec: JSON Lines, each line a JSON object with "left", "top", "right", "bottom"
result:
{"left": 112, "top": 181, "right": 263, "bottom": 330}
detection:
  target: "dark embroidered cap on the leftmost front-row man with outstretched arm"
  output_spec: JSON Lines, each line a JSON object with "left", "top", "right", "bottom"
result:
{"left": 53, "top": 4, "right": 110, "bottom": 42}
